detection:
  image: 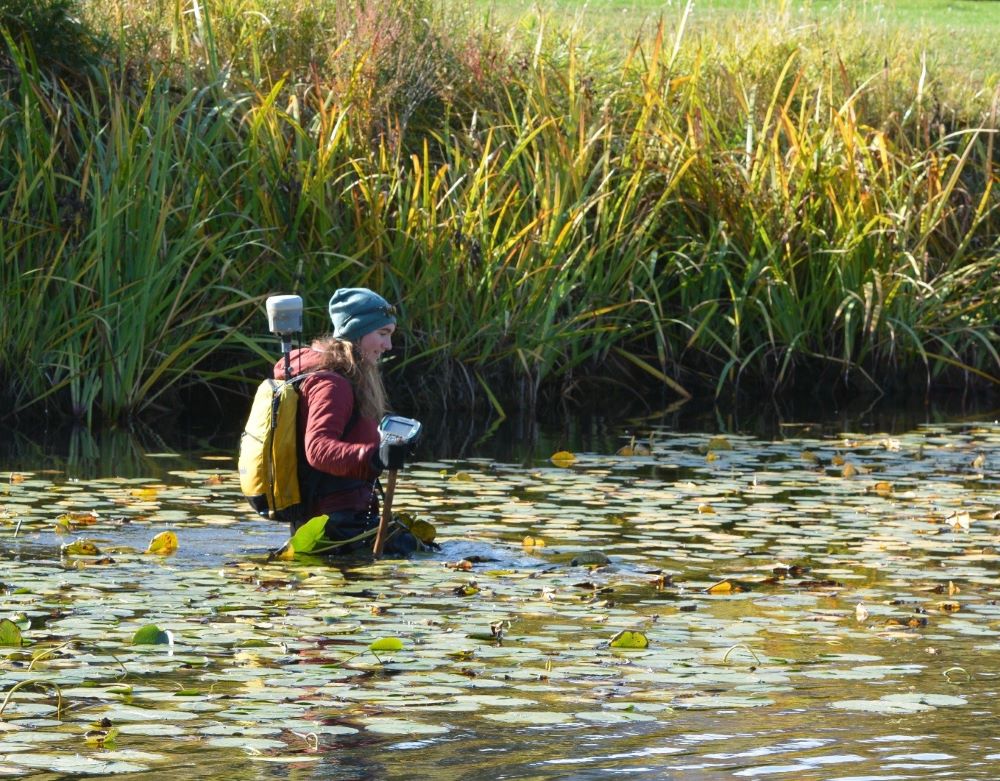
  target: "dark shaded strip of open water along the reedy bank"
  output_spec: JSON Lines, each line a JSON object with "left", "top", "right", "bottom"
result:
{"left": 0, "top": 394, "right": 1000, "bottom": 479}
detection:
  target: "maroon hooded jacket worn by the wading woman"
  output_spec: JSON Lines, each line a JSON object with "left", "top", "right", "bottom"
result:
{"left": 274, "top": 347, "right": 379, "bottom": 515}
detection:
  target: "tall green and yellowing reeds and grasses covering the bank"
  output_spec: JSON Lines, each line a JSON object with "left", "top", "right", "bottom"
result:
{"left": 0, "top": 0, "right": 1000, "bottom": 424}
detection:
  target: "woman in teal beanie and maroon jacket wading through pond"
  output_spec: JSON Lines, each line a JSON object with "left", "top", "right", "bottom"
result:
{"left": 274, "top": 288, "right": 417, "bottom": 553}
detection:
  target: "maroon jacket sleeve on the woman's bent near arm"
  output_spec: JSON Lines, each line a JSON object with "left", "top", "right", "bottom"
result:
{"left": 299, "top": 374, "right": 378, "bottom": 480}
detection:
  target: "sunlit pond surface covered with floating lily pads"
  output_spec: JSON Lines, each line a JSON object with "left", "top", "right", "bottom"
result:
{"left": 0, "top": 406, "right": 1000, "bottom": 780}
